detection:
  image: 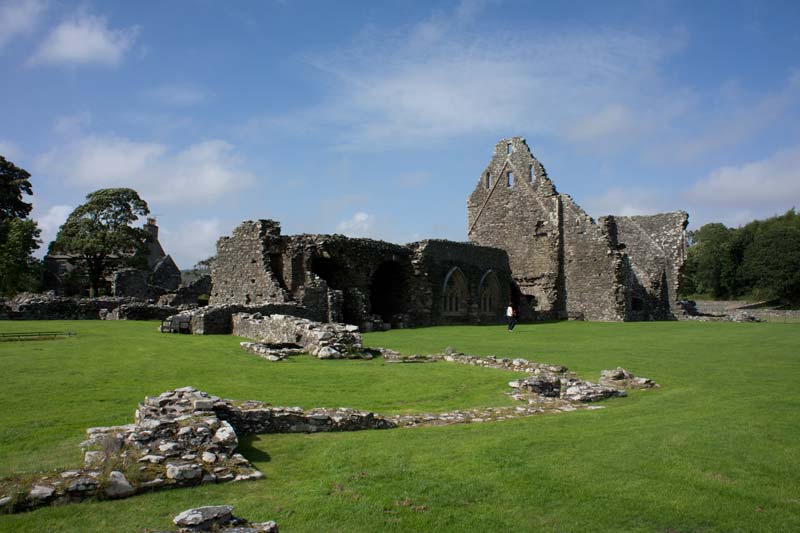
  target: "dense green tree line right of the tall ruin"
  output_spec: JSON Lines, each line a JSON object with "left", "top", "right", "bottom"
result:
{"left": 681, "top": 208, "right": 800, "bottom": 304}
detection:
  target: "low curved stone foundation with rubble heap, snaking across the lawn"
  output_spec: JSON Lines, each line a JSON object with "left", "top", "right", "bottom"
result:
{"left": 0, "top": 349, "right": 658, "bottom": 512}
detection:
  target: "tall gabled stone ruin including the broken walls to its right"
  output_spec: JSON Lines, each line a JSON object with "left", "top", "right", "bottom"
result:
{"left": 467, "top": 137, "right": 687, "bottom": 320}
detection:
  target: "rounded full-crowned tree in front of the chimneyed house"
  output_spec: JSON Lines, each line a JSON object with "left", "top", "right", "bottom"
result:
{"left": 50, "top": 188, "right": 150, "bottom": 296}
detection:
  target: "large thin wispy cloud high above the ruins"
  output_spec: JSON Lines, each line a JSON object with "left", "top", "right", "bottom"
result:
{"left": 246, "top": 6, "right": 685, "bottom": 152}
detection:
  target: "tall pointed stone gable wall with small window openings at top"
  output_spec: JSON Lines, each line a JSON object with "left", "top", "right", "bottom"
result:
{"left": 467, "top": 137, "right": 564, "bottom": 319}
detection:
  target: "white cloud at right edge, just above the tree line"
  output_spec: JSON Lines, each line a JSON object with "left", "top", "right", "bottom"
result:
{"left": 686, "top": 146, "right": 800, "bottom": 211}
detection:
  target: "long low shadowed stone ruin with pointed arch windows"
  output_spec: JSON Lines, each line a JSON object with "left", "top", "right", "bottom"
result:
{"left": 208, "top": 220, "right": 510, "bottom": 331}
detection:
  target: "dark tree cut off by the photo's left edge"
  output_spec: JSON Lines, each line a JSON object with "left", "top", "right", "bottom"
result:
{"left": 0, "top": 156, "right": 41, "bottom": 296}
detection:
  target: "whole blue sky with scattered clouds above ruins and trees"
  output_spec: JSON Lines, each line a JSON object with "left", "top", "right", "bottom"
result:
{"left": 0, "top": 0, "right": 800, "bottom": 268}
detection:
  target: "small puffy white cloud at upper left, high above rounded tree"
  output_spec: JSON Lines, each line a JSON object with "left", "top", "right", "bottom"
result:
{"left": 30, "top": 13, "right": 139, "bottom": 66}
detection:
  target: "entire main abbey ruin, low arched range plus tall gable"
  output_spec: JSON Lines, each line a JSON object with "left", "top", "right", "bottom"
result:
{"left": 209, "top": 137, "right": 688, "bottom": 330}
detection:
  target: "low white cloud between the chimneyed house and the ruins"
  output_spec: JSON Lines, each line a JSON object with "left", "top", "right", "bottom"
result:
{"left": 158, "top": 218, "right": 224, "bottom": 269}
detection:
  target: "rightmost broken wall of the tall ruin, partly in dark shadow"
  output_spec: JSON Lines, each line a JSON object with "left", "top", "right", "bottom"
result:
{"left": 614, "top": 211, "right": 689, "bottom": 320}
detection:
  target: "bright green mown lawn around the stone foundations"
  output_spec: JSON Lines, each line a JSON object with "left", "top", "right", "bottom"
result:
{"left": 0, "top": 321, "right": 800, "bottom": 532}
